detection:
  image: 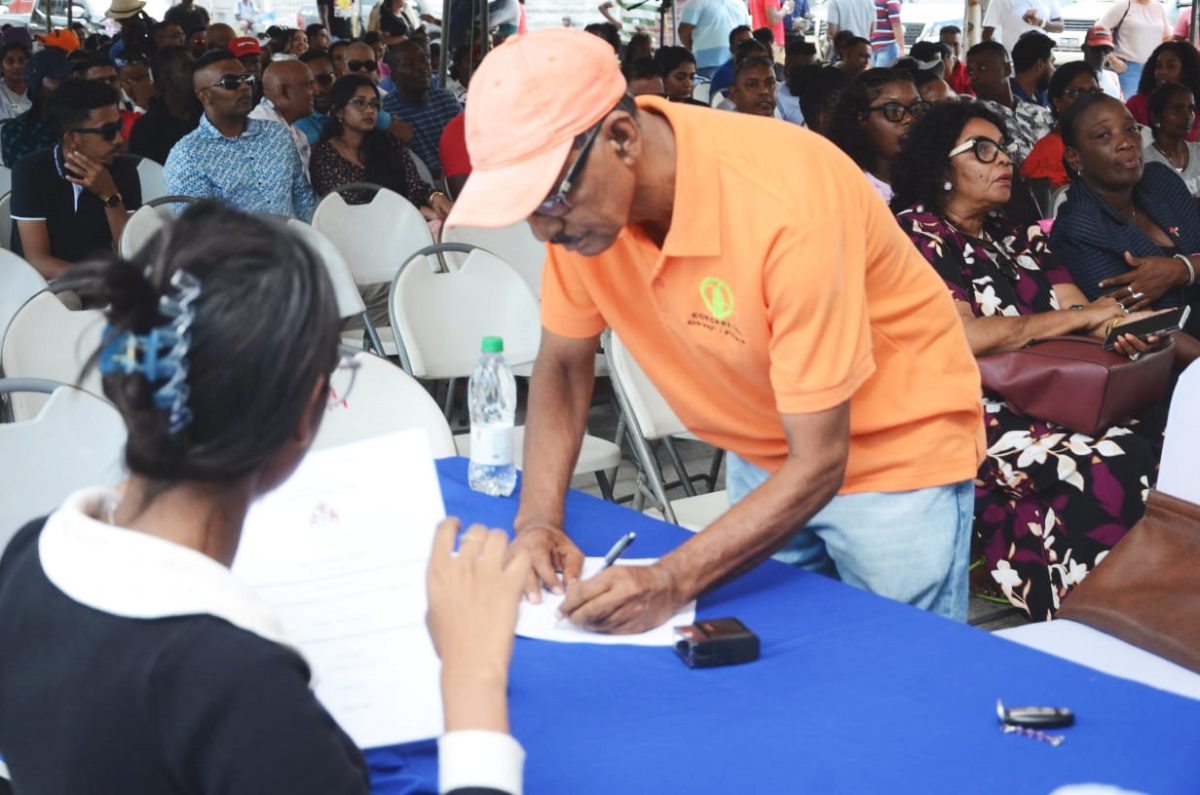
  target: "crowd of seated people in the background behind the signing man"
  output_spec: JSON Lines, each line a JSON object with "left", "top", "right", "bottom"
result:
{"left": 7, "top": 4, "right": 1200, "bottom": 638}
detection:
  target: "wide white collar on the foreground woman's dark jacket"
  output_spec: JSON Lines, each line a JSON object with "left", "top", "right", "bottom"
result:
{"left": 37, "top": 489, "right": 302, "bottom": 656}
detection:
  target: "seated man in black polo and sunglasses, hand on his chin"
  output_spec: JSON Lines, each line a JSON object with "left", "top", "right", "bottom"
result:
{"left": 12, "top": 79, "right": 142, "bottom": 279}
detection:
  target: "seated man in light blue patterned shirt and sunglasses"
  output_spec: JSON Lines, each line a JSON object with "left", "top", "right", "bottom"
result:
{"left": 164, "top": 50, "right": 317, "bottom": 221}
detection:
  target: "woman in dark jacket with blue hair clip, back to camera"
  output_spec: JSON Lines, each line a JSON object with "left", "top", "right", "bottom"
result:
{"left": 0, "top": 202, "right": 529, "bottom": 795}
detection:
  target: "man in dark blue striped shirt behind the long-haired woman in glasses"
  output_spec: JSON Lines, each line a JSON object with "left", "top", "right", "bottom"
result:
{"left": 383, "top": 40, "right": 462, "bottom": 175}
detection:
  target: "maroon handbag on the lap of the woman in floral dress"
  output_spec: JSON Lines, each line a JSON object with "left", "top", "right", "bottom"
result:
{"left": 977, "top": 336, "right": 1175, "bottom": 436}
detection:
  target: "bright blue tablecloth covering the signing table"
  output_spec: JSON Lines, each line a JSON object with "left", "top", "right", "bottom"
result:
{"left": 367, "top": 459, "right": 1200, "bottom": 795}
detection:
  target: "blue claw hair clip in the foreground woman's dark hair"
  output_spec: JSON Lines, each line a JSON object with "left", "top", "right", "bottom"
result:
{"left": 100, "top": 270, "right": 200, "bottom": 436}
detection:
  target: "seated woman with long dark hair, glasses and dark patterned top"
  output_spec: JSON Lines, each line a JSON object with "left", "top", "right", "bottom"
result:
{"left": 308, "top": 74, "right": 450, "bottom": 221}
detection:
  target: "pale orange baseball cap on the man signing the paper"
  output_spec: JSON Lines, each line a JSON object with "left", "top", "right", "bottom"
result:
{"left": 446, "top": 28, "right": 625, "bottom": 227}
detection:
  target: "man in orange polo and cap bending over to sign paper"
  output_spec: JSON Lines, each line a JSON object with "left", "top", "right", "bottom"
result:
{"left": 449, "top": 30, "right": 983, "bottom": 633}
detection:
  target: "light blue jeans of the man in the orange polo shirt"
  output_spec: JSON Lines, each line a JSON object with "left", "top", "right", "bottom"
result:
{"left": 725, "top": 453, "right": 974, "bottom": 621}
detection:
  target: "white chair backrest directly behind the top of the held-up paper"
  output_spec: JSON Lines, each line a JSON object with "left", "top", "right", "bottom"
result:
{"left": 313, "top": 352, "right": 458, "bottom": 459}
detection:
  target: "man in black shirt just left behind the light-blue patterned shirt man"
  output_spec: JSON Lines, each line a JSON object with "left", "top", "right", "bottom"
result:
{"left": 130, "top": 46, "right": 200, "bottom": 165}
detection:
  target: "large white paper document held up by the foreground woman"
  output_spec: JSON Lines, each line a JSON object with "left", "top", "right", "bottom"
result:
{"left": 233, "top": 429, "right": 445, "bottom": 748}
